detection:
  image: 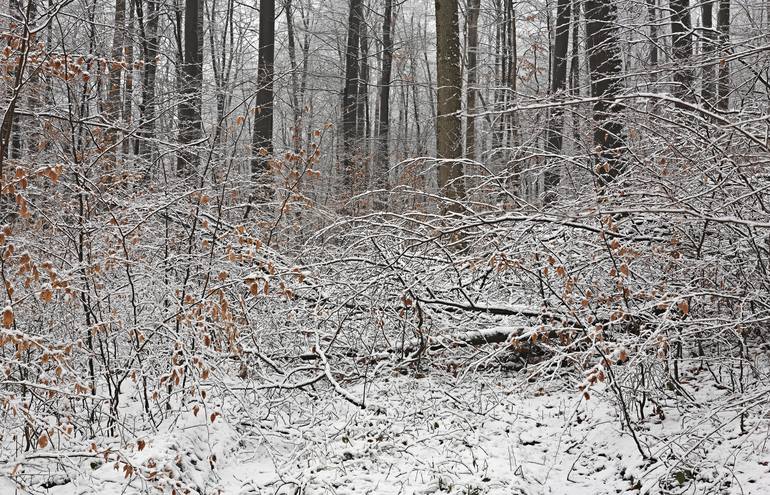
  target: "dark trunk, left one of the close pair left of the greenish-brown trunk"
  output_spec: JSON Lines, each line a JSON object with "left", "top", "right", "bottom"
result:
{"left": 342, "top": 0, "right": 363, "bottom": 195}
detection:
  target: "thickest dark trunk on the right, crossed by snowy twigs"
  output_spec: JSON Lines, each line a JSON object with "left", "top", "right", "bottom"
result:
{"left": 585, "top": 0, "right": 625, "bottom": 188}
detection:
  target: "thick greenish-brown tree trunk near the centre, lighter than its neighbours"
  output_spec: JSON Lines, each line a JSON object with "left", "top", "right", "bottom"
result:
{"left": 436, "top": 0, "right": 465, "bottom": 212}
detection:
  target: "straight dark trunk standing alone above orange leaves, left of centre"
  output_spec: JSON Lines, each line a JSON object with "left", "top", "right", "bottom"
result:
{"left": 251, "top": 0, "right": 275, "bottom": 178}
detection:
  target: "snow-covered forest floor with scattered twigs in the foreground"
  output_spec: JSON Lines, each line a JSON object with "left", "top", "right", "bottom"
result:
{"left": 25, "top": 373, "right": 770, "bottom": 495}
